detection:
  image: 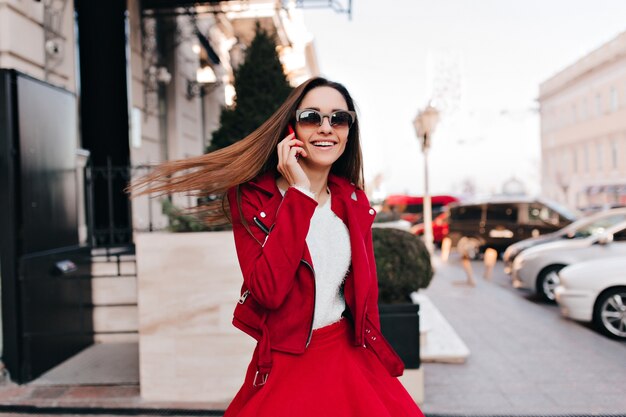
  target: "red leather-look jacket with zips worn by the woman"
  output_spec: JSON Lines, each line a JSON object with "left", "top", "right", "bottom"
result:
{"left": 228, "top": 172, "right": 404, "bottom": 384}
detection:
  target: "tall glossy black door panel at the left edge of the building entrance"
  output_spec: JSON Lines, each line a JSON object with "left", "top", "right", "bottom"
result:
{"left": 0, "top": 70, "right": 93, "bottom": 382}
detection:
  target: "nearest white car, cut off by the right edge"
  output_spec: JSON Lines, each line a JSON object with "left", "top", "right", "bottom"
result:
{"left": 554, "top": 257, "right": 626, "bottom": 340}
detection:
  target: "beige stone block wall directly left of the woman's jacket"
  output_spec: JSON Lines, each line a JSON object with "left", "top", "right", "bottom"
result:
{"left": 136, "top": 232, "right": 255, "bottom": 408}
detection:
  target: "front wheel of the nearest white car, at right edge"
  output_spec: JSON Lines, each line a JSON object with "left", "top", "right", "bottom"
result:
{"left": 593, "top": 287, "right": 626, "bottom": 340}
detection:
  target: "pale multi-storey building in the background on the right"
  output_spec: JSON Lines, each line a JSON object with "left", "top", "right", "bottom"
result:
{"left": 539, "top": 32, "right": 626, "bottom": 210}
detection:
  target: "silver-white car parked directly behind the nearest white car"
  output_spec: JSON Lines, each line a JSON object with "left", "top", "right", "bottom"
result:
{"left": 512, "top": 222, "right": 626, "bottom": 301}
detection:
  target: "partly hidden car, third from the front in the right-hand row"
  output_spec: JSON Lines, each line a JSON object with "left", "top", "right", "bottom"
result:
{"left": 502, "top": 207, "right": 626, "bottom": 274}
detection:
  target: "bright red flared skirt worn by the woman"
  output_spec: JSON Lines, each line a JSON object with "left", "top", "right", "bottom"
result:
{"left": 224, "top": 319, "right": 424, "bottom": 417}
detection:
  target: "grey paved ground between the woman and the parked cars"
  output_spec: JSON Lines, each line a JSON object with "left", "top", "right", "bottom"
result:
{"left": 422, "top": 255, "right": 626, "bottom": 415}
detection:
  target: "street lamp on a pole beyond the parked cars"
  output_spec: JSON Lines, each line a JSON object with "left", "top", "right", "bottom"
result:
{"left": 413, "top": 103, "right": 439, "bottom": 255}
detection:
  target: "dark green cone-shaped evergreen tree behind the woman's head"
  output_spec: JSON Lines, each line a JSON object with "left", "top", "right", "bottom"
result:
{"left": 207, "top": 22, "right": 291, "bottom": 152}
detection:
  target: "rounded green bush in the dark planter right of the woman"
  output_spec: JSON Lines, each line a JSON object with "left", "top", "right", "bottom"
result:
{"left": 372, "top": 228, "right": 433, "bottom": 304}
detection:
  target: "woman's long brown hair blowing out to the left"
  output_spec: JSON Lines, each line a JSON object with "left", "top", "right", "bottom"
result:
{"left": 128, "top": 77, "right": 363, "bottom": 225}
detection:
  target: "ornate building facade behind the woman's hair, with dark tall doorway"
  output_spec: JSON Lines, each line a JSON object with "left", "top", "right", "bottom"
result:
{"left": 0, "top": 0, "right": 319, "bottom": 380}
